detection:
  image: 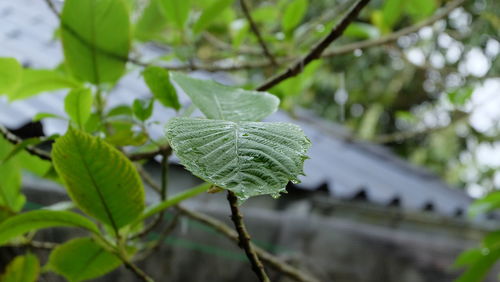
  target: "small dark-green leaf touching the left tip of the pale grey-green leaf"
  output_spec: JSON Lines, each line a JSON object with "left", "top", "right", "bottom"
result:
{"left": 142, "top": 66, "right": 181, "bottom": 110}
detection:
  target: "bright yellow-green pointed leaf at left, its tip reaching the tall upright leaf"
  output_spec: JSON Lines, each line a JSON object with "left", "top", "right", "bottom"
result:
{"left": 8, "top": 69, "right": 81, "bottom": 100}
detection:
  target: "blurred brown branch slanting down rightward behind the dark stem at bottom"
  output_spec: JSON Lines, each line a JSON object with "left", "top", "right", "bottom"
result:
{"left": 176, "top": 205, "right": 319, "bottom": 282}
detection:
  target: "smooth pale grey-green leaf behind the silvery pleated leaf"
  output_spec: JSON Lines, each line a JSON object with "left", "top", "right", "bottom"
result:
{"left": 170, "top": 73, "right": 279, "bottom": 121}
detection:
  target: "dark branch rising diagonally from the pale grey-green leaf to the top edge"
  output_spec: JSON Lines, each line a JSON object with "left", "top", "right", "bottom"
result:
{"left": 257, "top": 0, "right": 370, "bottom": 91}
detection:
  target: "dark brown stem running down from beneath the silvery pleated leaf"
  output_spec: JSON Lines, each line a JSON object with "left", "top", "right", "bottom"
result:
{"left": 227, "top": 191, "right": 271, "bottom": 282}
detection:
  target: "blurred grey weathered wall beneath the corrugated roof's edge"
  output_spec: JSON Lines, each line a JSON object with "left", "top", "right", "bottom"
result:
{"left": 0, "top": 187, "right": 493, "bottom": 282}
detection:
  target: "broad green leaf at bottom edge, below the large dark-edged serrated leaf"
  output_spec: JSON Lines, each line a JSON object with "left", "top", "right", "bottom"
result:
{"left": 47, "top": 238, "right": 122, "bottom": 281}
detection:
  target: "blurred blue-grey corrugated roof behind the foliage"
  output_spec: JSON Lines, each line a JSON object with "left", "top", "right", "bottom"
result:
{"left": 0, "top": 0, "right": 471, "bottom": 216}
